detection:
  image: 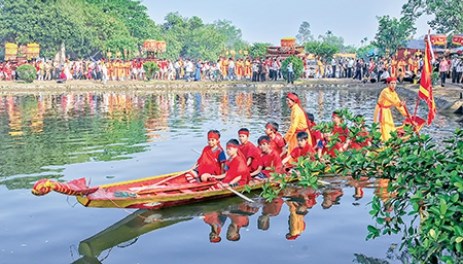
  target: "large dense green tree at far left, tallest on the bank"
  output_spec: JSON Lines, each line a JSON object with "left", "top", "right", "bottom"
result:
{"left": 0, "top": 0, "right": 159, "bottom": 57}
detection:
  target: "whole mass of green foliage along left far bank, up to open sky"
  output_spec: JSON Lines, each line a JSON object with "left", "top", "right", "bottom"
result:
{"left": 0, "top": 0, "right": 248, "bottom": 60}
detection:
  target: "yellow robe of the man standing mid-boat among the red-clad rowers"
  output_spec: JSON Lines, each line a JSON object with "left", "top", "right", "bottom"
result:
{"left": 285, "top": 104, "right": 312, "bottom": 154}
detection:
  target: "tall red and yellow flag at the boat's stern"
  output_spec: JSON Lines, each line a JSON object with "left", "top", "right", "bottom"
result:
{"left": 418, "top": 35, "right": 436, "bottom": 125}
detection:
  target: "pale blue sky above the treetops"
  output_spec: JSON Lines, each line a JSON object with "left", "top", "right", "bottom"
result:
{"left": 146, "top": 0, "right": 429, "bottom": 46}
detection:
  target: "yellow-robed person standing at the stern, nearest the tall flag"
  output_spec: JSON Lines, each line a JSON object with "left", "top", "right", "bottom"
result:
{"left": 373, "top": 77, "right": 407, "bottom": 142}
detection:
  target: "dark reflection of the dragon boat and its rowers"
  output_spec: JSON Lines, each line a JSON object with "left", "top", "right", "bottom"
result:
{"left": 74, "top": 182, "right": 402, "bottom": 263}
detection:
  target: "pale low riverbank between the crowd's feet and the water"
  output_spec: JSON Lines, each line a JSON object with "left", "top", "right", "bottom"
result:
{"left": 0, "top": 79, "right": 463, "bottom": 114}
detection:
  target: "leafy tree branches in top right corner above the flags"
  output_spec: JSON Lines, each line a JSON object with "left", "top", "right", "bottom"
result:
{"left": 402, "top": 0, "right": 463, "bottom": 34}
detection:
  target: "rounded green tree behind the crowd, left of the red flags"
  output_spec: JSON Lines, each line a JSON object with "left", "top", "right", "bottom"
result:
{"left": 373, "top": 16, "right": 415, "bottom": 54}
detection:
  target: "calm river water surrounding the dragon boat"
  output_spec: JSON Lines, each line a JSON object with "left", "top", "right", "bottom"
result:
{"left": 0, "top": 87, "right": 460, "bottom": 264}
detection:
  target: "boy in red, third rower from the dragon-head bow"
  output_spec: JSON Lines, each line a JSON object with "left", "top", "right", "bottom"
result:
{"left": 238, "top": 128, "right": 262, "bottom": 178}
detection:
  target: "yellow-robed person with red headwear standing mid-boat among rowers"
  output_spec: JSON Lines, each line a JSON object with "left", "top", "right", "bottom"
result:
{"left": 284, "top": 93, "right": 312, "bottom": 154}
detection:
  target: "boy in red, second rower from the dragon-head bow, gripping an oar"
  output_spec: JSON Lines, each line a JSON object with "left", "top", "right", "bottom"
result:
{"left": 201, "top": 139, "right": 251, "bottom": 190}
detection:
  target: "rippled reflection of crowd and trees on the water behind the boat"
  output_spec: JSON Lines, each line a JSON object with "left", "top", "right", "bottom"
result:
{"left": 0, "top": 89, "right": 457, "bottom": 191}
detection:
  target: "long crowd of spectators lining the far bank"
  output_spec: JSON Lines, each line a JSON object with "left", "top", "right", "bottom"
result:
{"left": 0, "top": 55, "right": 463, "bottom": 85}
